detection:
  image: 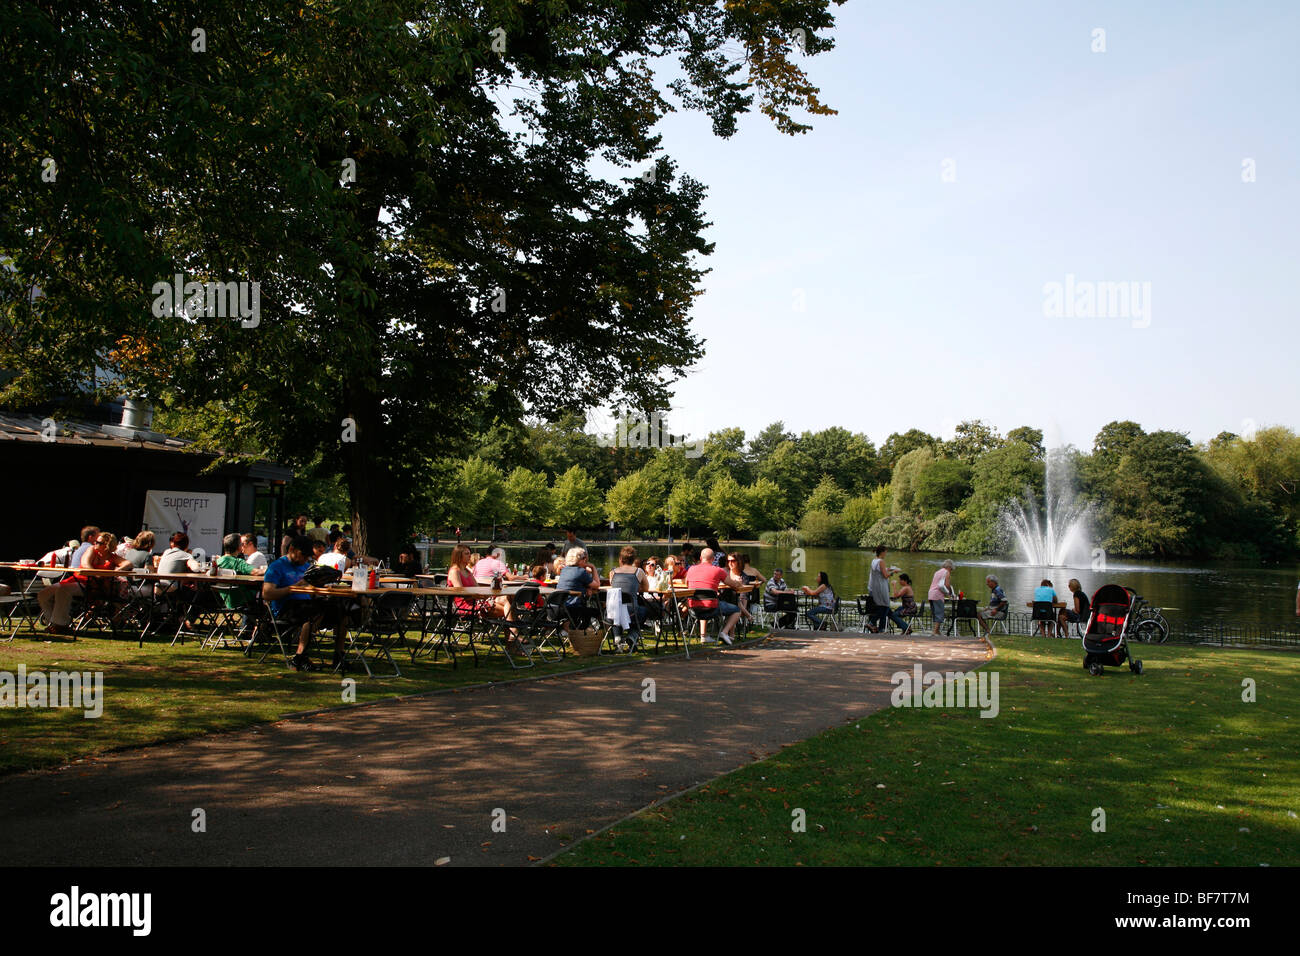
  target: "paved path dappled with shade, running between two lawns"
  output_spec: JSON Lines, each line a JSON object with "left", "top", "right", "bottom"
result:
{"left": 0, "top": 631, "right": 987, "bottom": 866}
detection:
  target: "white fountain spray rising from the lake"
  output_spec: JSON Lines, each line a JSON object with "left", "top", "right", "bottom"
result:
{"left": 1000, "top": 449, "right": 1092, "bottom": 567}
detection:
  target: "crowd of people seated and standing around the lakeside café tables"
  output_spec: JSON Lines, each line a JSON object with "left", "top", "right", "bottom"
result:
{"left": 15, "top": 514, "right": 1112, "bottom": 667}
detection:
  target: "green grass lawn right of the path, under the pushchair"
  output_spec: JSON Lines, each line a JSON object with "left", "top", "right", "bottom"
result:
{"left": 559, "top": 637, "right": 1300, "bottom": 866}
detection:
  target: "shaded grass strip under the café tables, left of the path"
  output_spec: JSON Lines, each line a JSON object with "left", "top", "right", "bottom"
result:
{"left": 0, "top": 631, "right": 707, "bottom": 773}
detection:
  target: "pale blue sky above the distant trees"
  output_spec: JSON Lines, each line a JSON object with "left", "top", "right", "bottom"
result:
{"left": 624, "top": 0, "right": 1300, "bottom": 449}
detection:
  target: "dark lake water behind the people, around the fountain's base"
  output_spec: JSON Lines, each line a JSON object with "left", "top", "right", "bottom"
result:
{"left": 421, "top": 542, "right": 1300, "bottom": 630}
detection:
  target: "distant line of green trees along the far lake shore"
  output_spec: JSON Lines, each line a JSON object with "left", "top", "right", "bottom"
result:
{"left": 294, "top": 412, "right": 1300, "bottom": 561}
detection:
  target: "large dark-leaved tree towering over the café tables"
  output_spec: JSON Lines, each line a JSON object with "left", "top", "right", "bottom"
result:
{"left": 0, "top": 0, "right": 841, "bottom": 553}
